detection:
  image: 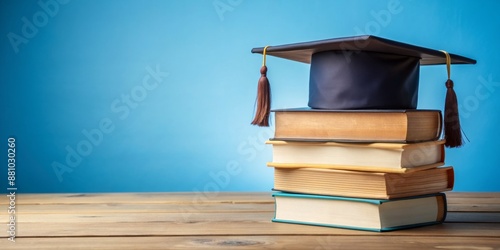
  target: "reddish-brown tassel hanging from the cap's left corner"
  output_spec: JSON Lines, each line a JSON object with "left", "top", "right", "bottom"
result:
{"left": 252, "top": 65, "right": 271, "bottom": 127}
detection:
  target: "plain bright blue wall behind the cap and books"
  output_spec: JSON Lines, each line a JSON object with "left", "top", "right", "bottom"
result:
{"left": 0, "top": 0, "right": 500, "bottom": 193}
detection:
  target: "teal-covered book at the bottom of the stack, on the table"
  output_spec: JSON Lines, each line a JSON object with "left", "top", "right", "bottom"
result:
{"left": 273, "top": 192, "right": 447, "bottom": 232}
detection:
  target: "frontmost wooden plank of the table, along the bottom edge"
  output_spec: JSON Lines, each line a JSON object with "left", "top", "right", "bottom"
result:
{"left": 3, "top": 235, "right": 500, "bottom": 250}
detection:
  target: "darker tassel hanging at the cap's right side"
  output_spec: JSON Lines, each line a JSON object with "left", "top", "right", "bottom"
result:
{"left": 444, "top": 79, "right": 463, "bottom": 148}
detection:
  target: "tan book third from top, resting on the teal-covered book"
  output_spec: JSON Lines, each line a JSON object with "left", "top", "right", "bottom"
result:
{"left": 274, "top": 167, "right": 454, "bottom": 199}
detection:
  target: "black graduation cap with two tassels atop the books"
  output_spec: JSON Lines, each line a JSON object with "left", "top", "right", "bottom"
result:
{"left": 252, "top": 35, "right": 476, "bottom": 147}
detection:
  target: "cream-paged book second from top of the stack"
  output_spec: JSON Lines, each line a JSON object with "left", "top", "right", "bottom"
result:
{"left": 267, "top": 140, "right": 444, "bottom": 173}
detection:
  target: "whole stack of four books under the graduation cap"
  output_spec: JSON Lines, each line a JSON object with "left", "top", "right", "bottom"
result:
{"left": 267, "top": 108, "right": 454, "bottom": 232}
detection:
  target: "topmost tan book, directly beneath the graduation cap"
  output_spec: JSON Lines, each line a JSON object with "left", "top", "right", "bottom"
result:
{"left": 273, "top": 108, "right": 442, "bottom": 142}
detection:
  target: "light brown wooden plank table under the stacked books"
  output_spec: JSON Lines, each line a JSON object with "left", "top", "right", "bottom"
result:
{"left": 0, "top": 192, "right": 500, "bottom": 250}
